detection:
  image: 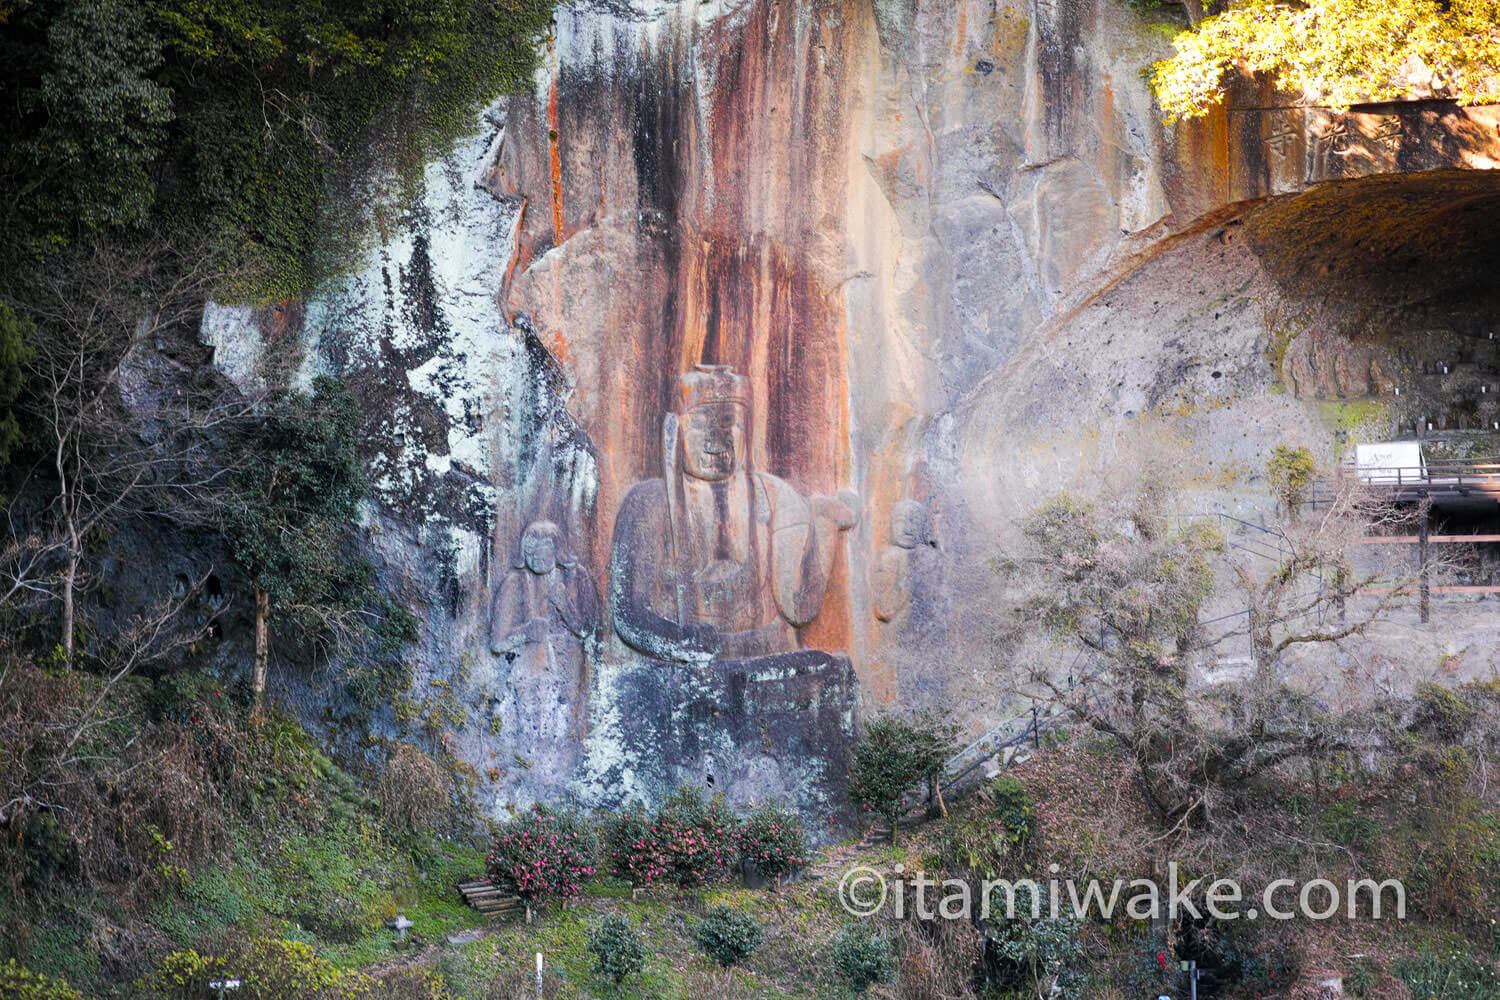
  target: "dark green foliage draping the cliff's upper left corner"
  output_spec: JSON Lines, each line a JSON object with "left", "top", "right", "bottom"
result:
{"left": 0, "top": 0, "right": 551, "bottom": 300}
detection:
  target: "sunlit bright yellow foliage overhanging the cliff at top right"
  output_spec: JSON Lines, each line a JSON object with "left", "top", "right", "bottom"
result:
{"left": 1151, "top": 0, "right": 1500, "bottom": 121}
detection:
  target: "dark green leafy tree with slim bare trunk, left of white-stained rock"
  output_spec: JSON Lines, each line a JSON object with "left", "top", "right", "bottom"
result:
{"left": 225, "top": 375, "right": 371, "bottom": 706}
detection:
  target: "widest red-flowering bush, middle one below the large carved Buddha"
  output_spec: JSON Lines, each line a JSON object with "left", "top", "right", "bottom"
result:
{"left": 608, "top": 789, "right": 740, "bottom": 889}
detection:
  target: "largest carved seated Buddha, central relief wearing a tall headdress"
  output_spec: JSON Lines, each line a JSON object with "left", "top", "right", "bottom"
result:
{"left": 611, "top": 364, "right": 858, "bottom": 663}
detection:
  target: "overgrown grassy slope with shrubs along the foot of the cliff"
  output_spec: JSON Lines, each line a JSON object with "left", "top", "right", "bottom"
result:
{"left": 0, "top": 663, "right": 1500, "bottom": 1000}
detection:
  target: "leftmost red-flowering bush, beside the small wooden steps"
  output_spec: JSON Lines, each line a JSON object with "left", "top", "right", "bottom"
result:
{"left": 486, "top": 805, "right": 599, "bottom": 903}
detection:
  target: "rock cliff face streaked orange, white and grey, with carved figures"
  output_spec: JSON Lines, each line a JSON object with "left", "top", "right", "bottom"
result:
{"left": 206, "top": 0, "right": 1500, "bottom": 827}
